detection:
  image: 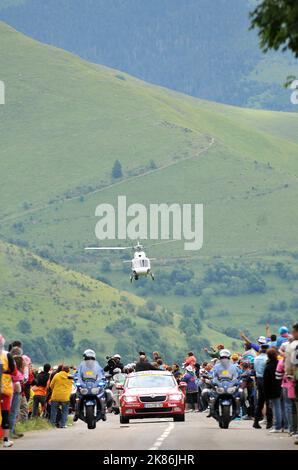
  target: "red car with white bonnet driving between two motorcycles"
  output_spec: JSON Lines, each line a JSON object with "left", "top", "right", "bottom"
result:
{"left": 118, "top": 370, "right": 186, "bottom": 424}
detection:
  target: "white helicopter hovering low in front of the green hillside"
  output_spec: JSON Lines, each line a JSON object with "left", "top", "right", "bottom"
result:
{"left": 85, "top": 241, "right": 155, "bottom": 282}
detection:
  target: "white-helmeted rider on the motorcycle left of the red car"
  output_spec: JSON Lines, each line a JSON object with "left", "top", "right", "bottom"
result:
{"left": 73, "top": 349, "right": 113, "bottom": 422}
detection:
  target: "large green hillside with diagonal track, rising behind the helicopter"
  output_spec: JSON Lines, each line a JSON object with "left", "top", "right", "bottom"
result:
{"left": 0, "top": 19, "right": 298, "bottom": 356}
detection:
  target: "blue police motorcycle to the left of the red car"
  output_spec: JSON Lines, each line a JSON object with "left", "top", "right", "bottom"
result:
{"left": 76, "top": 379, "right": 106, "bottom": 429}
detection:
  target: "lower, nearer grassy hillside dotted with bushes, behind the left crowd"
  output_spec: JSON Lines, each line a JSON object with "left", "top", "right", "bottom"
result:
{"left": 0, "top": 242, "right": 237, "bottom": 362}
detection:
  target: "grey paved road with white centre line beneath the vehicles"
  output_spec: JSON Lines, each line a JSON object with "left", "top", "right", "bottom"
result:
{"left": 9, "top": 413, "right": 298, "bottom": 450}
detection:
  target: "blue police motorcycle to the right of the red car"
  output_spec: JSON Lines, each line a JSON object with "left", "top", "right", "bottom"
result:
{"left": 210, "top": 379, "right": 240, "bottom": 429}
